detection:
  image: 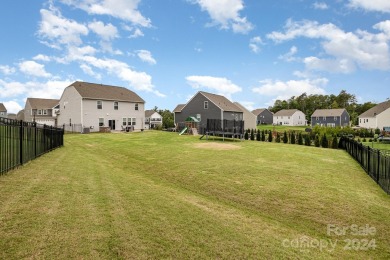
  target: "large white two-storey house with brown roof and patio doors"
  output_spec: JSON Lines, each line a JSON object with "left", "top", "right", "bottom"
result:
{"left": 58, "top": 81, "right": 145, "bottom": 132}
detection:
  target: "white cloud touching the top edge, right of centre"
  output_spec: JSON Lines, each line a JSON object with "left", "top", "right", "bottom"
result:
{"left": 191, "top": 0, "right": 253, "bottom": 34}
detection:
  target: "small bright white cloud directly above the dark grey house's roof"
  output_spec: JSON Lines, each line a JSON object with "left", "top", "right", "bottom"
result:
{"left": 186, "top": 76, "right": 242, "bottom": 99}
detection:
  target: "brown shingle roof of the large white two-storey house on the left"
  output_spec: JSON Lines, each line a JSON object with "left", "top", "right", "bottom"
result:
{"left": 71, "top": 81, "right": 145, "bottom": 103}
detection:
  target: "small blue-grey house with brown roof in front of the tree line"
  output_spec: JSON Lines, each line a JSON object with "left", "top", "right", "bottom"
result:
{"left": 311, "top": 108, "right": 350, "bottom": 127}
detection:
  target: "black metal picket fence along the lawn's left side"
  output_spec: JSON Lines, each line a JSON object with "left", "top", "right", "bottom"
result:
{"left": 0, "top": 117, "right": 64, "bottom": 175}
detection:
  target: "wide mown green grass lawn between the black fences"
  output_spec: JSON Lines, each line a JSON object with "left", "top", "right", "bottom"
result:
{"left": 0, "top": 131, "right": 390, "bottom": 259}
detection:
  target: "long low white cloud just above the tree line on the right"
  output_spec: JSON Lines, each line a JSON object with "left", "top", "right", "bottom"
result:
{"left": 252, "top": 78, "right": 328, "bottom": 100}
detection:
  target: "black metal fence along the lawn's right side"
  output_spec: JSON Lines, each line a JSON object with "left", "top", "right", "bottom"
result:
{"left": 339, "top": 137, "right": 390, "bottom": 194}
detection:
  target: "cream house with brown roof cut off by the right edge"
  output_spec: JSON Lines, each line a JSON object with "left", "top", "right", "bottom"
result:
{"left": 359, "top": 100, "right": 390, "bottom": 130}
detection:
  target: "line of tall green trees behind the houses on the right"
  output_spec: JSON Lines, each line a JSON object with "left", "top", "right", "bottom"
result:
{"left": 268, "top": 90, "right": 377, "bottom": 125}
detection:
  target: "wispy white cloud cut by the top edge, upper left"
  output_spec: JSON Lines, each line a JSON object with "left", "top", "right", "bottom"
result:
{"left": 62, "top": 0, "right": 152, "bottom": 27}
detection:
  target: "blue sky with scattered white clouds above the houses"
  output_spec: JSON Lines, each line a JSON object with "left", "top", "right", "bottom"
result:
{"left": 0, "top": 0, "right": 390, "bottom": 113}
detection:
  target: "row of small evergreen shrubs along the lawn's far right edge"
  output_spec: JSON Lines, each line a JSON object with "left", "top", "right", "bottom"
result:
{"left": 244, "top": 129, "right": 338, "bottom": 149}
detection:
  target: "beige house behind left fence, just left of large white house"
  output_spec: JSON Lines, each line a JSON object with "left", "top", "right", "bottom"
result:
{"left": 24, "top": 98, "right": 59, "bottom": 126}
